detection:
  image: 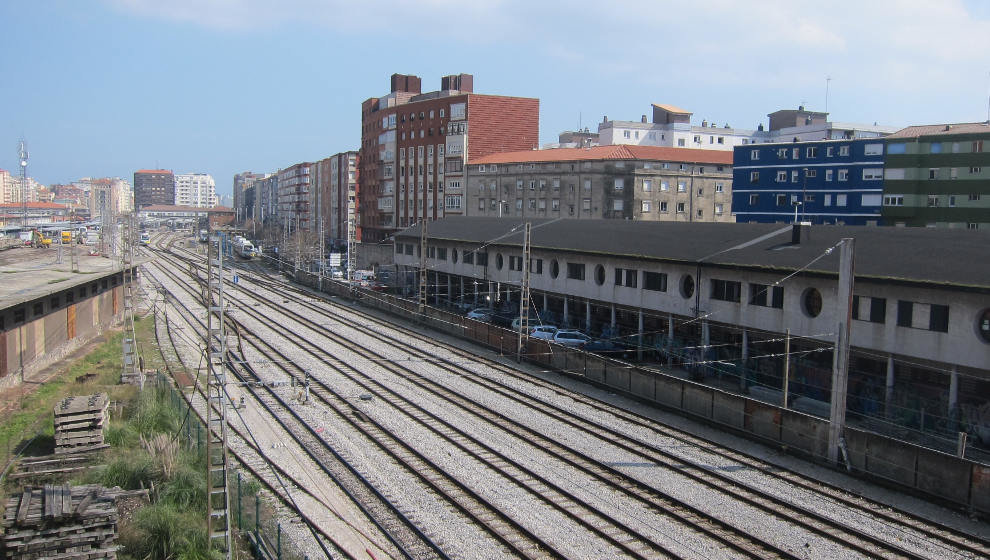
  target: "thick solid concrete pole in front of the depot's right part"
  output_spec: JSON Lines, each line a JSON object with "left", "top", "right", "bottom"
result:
{"left": 828, "top": 237, "right": 856, "bottom": 464}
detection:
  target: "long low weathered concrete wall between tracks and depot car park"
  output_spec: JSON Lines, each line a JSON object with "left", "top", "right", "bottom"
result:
{"left": 297, "top": 274, "right": 990, "bottom": 513}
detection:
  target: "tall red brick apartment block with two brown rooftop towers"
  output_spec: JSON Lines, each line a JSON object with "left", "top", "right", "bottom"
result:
{"left": 358, "top": 74, "right": 540, "bottom": 243}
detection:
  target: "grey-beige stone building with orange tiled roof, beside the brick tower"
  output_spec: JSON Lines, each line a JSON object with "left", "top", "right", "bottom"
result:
{"left": 466, "top": 146, "right": 732, "bottom": 222}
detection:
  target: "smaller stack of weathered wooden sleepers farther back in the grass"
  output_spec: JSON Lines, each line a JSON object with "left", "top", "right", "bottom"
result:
{"left": 55, "top": 393, "right": 110, "bottom": 453}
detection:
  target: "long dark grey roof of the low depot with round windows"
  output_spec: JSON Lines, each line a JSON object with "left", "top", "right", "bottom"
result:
{"left": 396, "top": 216, "right": 990, "bottom": 292}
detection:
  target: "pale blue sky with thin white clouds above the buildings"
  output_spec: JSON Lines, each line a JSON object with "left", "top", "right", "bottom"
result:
{"left": 0, "top": 0, "right": 990, "bottom": 199}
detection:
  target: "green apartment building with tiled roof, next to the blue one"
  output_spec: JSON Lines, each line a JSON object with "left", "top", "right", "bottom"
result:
{"left": 882, "top": 122, "right": 990, "bottom": 229}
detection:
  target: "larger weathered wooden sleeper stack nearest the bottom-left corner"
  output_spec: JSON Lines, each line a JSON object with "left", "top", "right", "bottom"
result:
{"left": 0, "top": 484, "right": 133, "bottom": 560}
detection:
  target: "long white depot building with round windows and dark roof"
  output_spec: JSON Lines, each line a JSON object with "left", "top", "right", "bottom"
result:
{"left": 395, "top": 217, "right": 990, "bottom": 446}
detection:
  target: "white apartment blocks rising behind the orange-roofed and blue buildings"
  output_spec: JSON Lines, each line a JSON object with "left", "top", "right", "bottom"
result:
{"left": 598, "top": 103, "right": 899, "bottom": 151}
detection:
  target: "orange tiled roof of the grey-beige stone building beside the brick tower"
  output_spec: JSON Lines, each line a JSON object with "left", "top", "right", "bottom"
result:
{"left": 468, "top": 144, "right": 732, "bottom": 165}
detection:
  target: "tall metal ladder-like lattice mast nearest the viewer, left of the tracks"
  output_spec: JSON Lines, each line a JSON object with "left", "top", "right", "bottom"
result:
{"left": 203, "top": 238, "right": 232, "bottom": 560}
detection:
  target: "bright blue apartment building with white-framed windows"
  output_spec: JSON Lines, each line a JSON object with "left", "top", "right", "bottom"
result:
{"left": 732, "top": 138, "right": 885, "bottom": 225}
